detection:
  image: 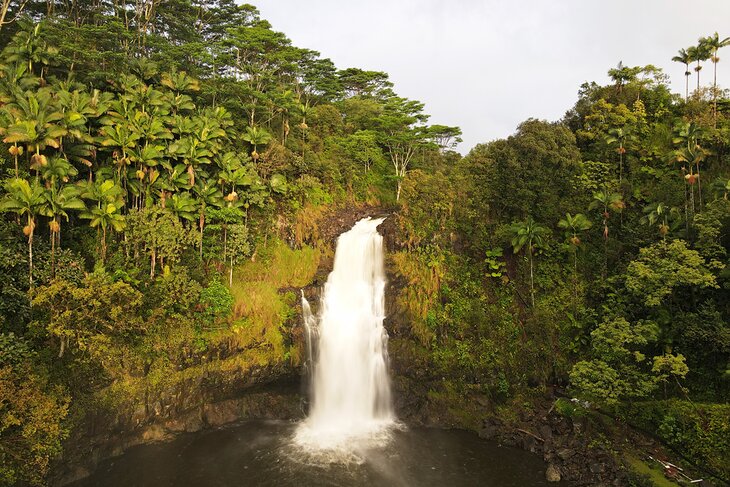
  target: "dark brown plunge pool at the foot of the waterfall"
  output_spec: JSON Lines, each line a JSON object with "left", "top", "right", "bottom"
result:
{"left": 72, "top": 421, "right": 556, "bottom": 487}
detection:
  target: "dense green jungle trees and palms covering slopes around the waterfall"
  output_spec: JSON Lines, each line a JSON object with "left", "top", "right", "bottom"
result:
{"left": 0, "top": 0, "right": 730, "bottom": 485}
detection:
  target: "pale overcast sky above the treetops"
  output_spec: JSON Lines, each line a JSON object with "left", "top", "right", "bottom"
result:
{"left": 251, "top": 0, "right": 730, "bottom": 154}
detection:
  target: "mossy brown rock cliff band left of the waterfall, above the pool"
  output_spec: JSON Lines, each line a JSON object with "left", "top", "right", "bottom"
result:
{"left": 51, "top": 350, "right": 304, "bottom": 485}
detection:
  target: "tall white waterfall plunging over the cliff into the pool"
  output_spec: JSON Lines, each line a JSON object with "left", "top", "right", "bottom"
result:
{"left": 295, "top": 218, "right": 394, "bottom": 450}
